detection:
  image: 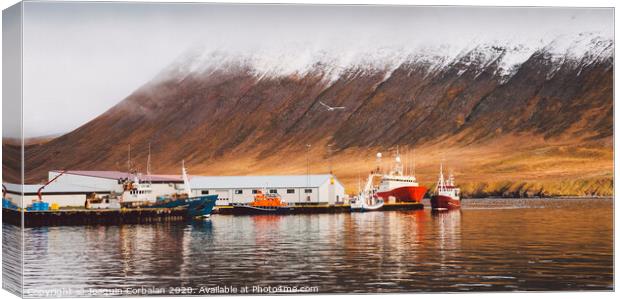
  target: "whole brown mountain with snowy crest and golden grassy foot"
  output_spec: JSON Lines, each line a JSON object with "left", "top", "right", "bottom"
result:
{"left": 3, "top": 33, "right": 614, "bottom": 195}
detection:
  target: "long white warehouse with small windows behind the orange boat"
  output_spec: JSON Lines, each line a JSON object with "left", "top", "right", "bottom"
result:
{"left": 190, "top": 174, "right": 345, "bottom": 206}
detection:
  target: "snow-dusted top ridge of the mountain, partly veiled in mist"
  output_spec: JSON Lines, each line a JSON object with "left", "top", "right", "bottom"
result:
{"left": 165, "top": 32, "right": 613, "bottom": 82}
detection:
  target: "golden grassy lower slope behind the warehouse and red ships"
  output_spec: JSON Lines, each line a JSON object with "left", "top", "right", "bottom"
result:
{"left": 180, "top": 136, "right": 613, "bottom": 197}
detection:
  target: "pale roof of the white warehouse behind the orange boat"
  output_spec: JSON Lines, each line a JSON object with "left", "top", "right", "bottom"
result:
{"left": 190, "top": 174, "right": 340, "bottom": 189}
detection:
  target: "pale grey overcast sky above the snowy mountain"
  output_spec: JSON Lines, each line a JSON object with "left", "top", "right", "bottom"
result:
{"left": 15, "top": 2, "right": 613, "bottom": 137}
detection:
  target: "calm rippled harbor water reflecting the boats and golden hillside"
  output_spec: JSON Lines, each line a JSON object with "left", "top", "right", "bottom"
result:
{"left": 4, "top": 199, "right": 613, "bottom": 296}
